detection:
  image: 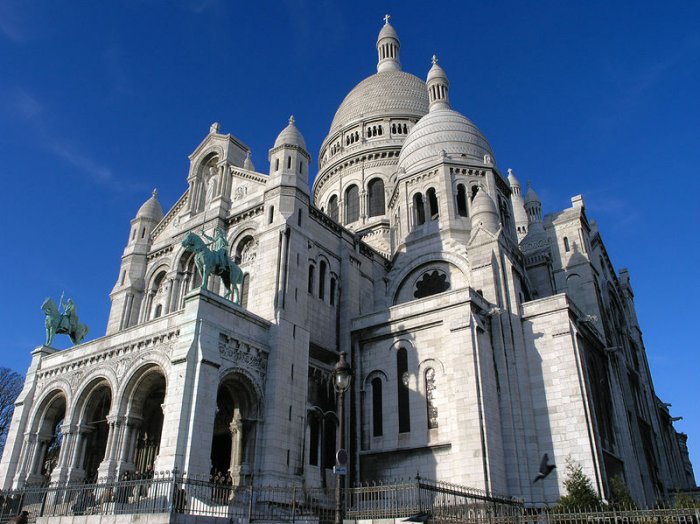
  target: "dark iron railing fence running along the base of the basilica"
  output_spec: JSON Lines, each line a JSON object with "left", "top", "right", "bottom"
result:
{"left": 0, "top": 472, "right": 700, "bottom": 524}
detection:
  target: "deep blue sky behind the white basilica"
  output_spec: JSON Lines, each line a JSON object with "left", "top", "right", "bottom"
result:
{"left": 0, "top": 0, "right": 700, "bottom": 470}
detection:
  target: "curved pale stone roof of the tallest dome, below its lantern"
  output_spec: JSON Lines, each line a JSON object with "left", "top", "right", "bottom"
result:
{"left": 330, "top": 70, "right": 428, "bottom": 133}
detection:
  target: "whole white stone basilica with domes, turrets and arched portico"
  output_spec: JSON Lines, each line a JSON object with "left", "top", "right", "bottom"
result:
{"left": 0, "top": 17, "right": 695, "bottom": 506}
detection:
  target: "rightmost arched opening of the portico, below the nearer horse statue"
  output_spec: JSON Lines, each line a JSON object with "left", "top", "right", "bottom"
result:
{"left": 211, "top": 373, "right": 258, "bottom": 485}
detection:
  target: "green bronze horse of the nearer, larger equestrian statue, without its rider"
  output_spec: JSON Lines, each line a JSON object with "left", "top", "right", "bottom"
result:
{"left": 182, "top": 231, "right": 243, "bottom": 305}
